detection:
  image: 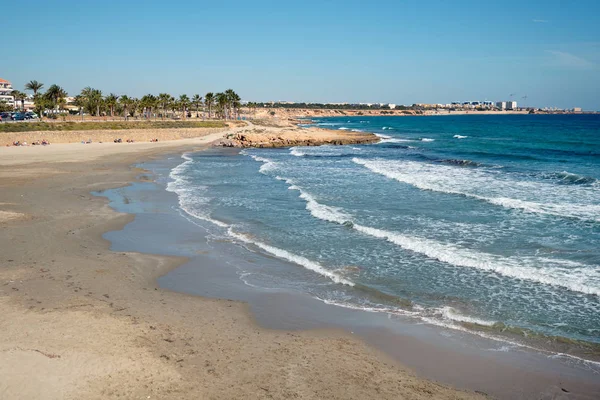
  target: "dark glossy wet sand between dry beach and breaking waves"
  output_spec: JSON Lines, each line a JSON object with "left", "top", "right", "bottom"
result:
{"left": 102, "top": 157, "right": 600, "bottom": 399}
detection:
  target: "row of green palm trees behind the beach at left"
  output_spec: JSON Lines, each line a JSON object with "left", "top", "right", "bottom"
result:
{"left": 18, "top": 80, "right": 241, "bottom": 119}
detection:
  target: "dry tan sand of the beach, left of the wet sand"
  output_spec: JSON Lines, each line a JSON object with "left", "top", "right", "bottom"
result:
{"left": 0, "top": 124, "right": 481, "bottom": 399}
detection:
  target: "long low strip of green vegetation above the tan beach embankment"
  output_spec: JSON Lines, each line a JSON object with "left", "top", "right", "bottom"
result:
{"left": 0, "top": 121, "right": 227, "bottom": 132}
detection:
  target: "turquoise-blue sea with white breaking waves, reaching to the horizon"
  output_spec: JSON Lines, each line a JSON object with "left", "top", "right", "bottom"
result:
{"left": 169, "top": 115, "right": 600, "bottom": 354}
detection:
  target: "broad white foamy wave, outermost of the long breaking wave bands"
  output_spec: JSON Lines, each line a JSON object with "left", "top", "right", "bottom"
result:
{"left": 352, "top": 158, "right": 600, "bottom": 222}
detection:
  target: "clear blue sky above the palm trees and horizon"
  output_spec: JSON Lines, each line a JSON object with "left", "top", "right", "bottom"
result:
{"left": 0, "top": 0, "right": 600, "bottom": 110}
